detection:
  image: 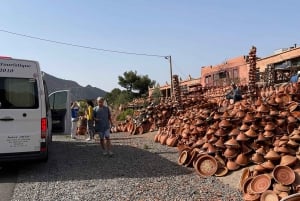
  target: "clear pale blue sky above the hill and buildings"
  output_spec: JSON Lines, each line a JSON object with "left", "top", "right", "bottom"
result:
{"left": 0, "top": 0, "right": 300, "bottom": 91}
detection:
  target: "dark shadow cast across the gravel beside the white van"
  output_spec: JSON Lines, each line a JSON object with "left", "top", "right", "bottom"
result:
{"left": 0, "top": 134, "right": 193, "bottom": 182}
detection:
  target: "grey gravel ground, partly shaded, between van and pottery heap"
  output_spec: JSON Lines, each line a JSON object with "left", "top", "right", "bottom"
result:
{"left": 12, "top": 133, "right": 242, "bottom": 201}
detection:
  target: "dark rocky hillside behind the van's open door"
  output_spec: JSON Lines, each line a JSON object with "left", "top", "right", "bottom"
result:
{"left": 44, "top": 73, "right": 106, "bottom": 100}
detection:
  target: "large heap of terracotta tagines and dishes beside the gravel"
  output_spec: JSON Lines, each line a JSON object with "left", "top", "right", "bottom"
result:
{"left": 150, "top": 81, "right": 300, "bottom": 200}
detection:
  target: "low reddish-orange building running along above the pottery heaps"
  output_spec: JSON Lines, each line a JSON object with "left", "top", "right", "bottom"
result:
{"left": 149, "top": 45, "right": 300, "bottom": 97}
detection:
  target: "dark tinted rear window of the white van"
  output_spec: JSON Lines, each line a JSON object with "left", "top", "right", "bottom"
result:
{"left": 0, "top": 77, "right": 39, "bottom": 109}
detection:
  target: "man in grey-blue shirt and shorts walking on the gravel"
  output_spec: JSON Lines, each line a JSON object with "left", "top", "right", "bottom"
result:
{"left": 94, "top": 97, "right": 113, "bottom": 156}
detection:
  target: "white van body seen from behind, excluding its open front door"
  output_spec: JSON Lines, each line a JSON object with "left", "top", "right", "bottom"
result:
{"left": 0, "top": 57, "right": 52, "bottom": 162}
